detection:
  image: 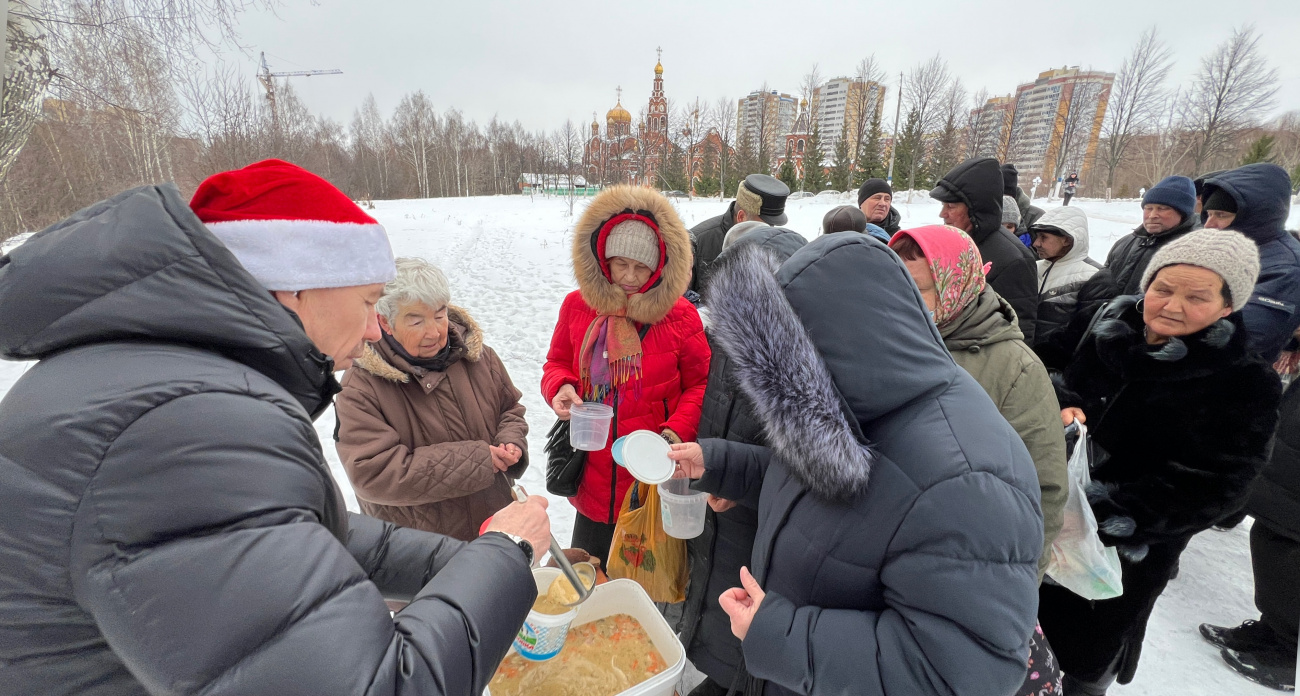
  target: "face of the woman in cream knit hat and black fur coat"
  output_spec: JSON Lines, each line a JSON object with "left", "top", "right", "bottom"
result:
{"left": 1141, "top": 264, "right": 1232, "bottom": 337}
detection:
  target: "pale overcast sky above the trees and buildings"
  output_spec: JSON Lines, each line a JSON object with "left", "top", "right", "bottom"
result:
{"left": 226, "top": 0, "right": 1300, "bottom": 130}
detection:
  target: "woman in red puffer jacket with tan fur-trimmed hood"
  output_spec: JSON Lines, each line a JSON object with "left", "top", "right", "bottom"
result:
{"left": 542, "top": 186, "right": 709, "bottom": 561}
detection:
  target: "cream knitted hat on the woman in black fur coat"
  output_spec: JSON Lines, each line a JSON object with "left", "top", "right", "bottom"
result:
{"left": 1141, "top": 229, "right": 1260, "bottom": 312}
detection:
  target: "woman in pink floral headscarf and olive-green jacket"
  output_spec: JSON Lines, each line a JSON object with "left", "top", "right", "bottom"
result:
{"left": 889, "top": 225, "right": 1069, "bottom": 693}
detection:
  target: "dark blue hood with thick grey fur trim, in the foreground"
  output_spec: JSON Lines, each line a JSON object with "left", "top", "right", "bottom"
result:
{"left": 706, "top": 234, "right": 959, "bottom": 500}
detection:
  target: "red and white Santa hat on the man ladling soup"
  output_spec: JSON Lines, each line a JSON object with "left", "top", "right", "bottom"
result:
{"left": 190, "top": 160, "right": 397, "bottom": 290}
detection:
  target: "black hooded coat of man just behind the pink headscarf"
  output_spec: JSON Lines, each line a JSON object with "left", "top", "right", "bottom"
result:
{"left": 936, "top": 157, "right": 1039, "bottom": 346}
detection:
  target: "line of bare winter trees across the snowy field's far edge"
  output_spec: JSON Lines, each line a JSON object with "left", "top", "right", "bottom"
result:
{"left": 0, "top": 0, "right": 1300, "bottom": 239}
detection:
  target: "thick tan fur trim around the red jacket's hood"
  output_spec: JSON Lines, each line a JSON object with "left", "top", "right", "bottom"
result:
{"left": 572, "top": 185, "right": 693, "bottom": 324}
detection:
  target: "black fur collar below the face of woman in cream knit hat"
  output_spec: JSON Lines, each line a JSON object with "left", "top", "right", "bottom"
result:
{"left": 1092, "top": 295, "right": 1249, "bottom": 381}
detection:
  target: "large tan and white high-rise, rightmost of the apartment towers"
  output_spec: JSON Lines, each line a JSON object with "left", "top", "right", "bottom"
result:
{"left": 1004, "top": 66, "right": 1115, "bottom": 181}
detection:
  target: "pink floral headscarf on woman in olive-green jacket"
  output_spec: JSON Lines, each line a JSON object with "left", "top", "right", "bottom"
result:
{"left": 889, "top": 225, "right": 993, "bottom": 329}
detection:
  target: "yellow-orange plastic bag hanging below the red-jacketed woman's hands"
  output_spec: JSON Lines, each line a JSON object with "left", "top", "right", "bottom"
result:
{"left": 606, "top": 483, "right": 689, "bottom": 604}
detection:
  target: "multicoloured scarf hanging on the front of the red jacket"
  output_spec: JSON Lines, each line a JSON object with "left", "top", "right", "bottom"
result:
{"left": 579, "top": 307, "right": 641, "bottom": 403}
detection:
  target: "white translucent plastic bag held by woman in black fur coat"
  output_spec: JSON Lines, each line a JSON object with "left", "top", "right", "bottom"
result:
{"left": 1048, "top": 423, "right": 1125, "bottom": 600}
